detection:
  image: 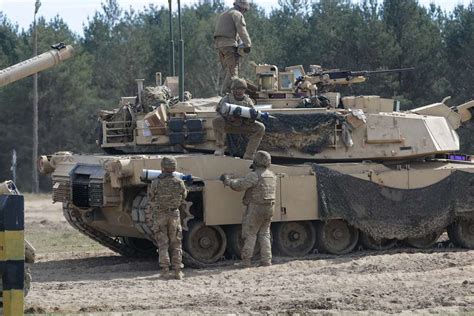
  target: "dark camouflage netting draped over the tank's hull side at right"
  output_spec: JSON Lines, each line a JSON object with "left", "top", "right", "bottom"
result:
{"left": 313, "top": 164, "right": 474, "bottom": 239}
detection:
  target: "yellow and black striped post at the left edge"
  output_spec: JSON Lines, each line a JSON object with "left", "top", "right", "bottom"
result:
{"left": 0, "top": 195, "right": 25, "bottom": 316}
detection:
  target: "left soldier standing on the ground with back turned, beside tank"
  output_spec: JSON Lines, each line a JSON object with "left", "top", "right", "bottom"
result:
{"left": 148, "top": 157, "right": 187, "bottom": 280}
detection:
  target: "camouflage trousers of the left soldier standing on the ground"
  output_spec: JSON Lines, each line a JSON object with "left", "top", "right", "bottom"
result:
{"left": 153, "top": 210, "right": 183, "bottom": 270}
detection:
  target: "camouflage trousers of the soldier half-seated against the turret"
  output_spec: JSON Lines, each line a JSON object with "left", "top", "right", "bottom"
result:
{"left": 212, "top": 115, "right": 265, "bottom": 159}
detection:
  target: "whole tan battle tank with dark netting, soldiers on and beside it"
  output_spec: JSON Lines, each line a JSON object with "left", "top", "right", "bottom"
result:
{"left": 39, "top": 65, "right": 474, "bottom": 264}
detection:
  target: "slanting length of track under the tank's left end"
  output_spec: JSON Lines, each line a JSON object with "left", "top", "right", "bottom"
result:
{"left": 63, "top": 204, "right": 149, "bottom": 258}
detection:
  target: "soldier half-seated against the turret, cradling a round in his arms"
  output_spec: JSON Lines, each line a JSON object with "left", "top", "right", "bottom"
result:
{"left": 212, "top": 78, "right": 265, "bottom": 160}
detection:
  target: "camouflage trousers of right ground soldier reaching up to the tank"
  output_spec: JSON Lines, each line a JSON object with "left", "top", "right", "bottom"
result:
{"left": 242, "top": 203, "right": 275, "bottom": 263}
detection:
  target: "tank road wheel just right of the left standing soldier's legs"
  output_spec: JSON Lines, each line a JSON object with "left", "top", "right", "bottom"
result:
{"left": 183, "top": 221, "right": 227, "bottom": 263}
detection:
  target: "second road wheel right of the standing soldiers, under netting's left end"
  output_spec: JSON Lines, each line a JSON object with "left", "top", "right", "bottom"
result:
{"left": 316, "top": 219, "right": 359, "bottom": 255}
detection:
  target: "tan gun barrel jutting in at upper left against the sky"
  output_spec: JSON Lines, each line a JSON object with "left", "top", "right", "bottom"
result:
{"left": 0, "top": 43, "right": 74, "bottom": 87}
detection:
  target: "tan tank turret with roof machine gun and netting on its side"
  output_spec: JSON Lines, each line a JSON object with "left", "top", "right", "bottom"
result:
{"left": 99, "top": 65, "right": 473, "bottom": 161}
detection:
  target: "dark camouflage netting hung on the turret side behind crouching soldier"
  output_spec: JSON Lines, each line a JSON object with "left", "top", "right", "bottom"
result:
{"left": 228, "top": 113, "right": 344, "bottom": 155}
